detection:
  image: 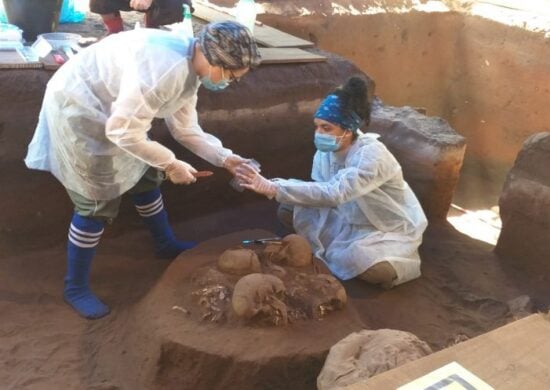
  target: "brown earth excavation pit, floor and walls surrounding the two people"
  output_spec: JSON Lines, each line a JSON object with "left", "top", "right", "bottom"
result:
{"left": 0, "top": 1, "right": 550, "bottom": 389}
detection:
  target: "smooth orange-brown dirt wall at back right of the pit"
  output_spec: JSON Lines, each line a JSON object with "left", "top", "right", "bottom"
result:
{"left": 260, "top": 6, "right": 550, "bottom": 204}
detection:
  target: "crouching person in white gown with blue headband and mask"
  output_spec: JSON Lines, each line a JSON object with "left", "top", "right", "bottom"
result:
{"left": 237, "top": 77, "right": 427, "bottom": 288}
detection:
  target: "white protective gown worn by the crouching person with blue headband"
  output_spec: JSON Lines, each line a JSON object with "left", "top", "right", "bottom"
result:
{"left": 276, "top": 134, "right": 427, "bottom": 285}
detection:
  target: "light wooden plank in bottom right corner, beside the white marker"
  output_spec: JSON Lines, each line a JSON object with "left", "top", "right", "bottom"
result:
{"left": 345, "top": 314, "right": 550, "bottom": 390}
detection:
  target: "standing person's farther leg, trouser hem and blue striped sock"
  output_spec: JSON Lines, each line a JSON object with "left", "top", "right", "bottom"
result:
{"left": 128, "top": 168, "right": 197, "bottom": 259}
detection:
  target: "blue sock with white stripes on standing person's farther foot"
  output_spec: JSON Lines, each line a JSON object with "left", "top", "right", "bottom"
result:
{"left": 132, "top": 188, "right": 197, "bottom": 259}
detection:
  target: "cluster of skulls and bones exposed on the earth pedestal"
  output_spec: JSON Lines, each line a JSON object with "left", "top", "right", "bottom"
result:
{"left": 182, "top": 234, "right": 347, "bottom": 326}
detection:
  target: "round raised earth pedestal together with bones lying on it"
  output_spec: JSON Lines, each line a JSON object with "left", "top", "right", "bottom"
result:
{"left": 117, "top": 230, "right": 364, "bottom": 389}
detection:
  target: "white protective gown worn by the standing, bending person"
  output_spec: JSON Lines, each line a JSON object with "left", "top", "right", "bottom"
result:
{"left": 25, "top": 29, "right": 232, "bottom": 200}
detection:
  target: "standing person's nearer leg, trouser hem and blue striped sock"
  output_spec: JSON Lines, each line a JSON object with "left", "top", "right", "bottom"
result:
{"left": 63, "top": 190, "right": 120, "bottom": 319}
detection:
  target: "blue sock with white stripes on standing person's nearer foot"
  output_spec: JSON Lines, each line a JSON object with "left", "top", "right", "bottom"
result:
{"left": 63, "top": 213, "right": 109, "bottom": 319}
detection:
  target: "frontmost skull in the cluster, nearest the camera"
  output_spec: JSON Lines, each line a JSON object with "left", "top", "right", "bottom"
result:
{"left": 231, "top": 273, "right": 288, "bottom": 325}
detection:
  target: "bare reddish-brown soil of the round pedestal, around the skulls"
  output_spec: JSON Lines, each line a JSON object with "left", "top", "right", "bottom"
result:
{"left": 110, "top": 230, "right": 363, "bottom": 390}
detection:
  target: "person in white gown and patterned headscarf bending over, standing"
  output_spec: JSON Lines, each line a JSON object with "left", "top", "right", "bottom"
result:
{"left": 25, "top": 22, "right": 260, "bottom": 319}
